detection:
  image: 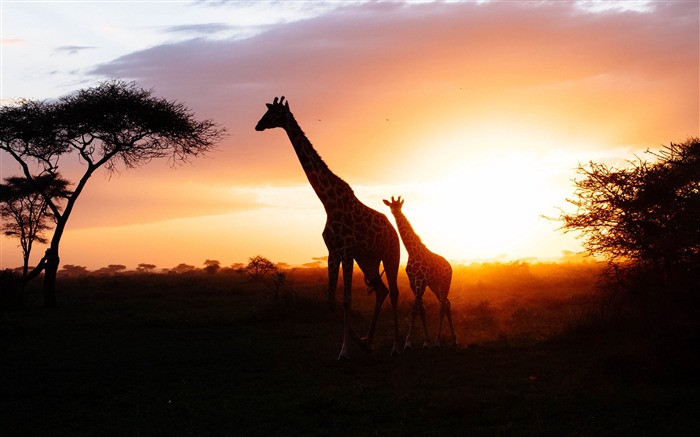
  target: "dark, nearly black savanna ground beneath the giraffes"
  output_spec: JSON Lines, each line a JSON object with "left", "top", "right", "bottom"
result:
{"left": 0, "top": 275, "right": 700, "bottom": 437}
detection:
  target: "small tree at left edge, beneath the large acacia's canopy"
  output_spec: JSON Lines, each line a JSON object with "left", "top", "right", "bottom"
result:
{"left": 0, "top": 174, "right": 71, "bottom": 285}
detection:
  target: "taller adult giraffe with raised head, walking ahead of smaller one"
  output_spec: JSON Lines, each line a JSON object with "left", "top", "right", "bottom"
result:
{"left": 255, "top": 96, "right": 401, "bottom": 359}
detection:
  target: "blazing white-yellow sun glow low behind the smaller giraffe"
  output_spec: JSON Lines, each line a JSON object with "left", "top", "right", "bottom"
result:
{"left": 394, "top": 129, "right": 571, "bottom": 261}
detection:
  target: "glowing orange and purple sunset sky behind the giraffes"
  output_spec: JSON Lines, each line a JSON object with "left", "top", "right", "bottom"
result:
{"left": 0, "top": 1, "right": 700, "bottom": 269}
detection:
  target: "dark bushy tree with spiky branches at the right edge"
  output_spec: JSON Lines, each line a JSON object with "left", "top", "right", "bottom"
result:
{"left": 560, "top": 138, "right": 700, "bottom": 316}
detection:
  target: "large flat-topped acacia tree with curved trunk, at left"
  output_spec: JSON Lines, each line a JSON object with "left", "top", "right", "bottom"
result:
{"left": 0, "top": 81, "right": 225, "bottom": 307}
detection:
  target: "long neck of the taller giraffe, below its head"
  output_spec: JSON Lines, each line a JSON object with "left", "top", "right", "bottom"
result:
{"left": 284, "top": 114, "right": 355, "bottom": 211}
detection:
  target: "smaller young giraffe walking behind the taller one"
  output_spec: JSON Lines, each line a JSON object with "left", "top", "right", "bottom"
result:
{"left": 384, "top": 196, "right": 457, "bottom": 349}
